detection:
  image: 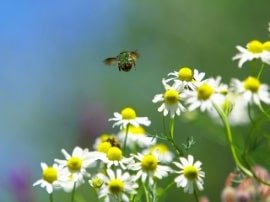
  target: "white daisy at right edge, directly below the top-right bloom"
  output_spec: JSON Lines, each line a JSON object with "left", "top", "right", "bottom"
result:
{"left": 231, "top": 76, "right": 270, "bottom": 106}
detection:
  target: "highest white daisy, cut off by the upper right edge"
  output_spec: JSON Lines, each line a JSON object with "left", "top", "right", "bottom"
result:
{"left": 233, "top": 40, "right": 270, "bottom": 68}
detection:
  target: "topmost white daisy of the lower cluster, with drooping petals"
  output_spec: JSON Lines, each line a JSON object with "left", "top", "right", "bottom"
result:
{"left": 109, "top": 107, "right": 151, "bottom": 129}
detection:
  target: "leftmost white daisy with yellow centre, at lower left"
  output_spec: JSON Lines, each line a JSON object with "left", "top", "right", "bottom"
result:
{"left": 33, "top": 163, "right": 62, "bottom": 194}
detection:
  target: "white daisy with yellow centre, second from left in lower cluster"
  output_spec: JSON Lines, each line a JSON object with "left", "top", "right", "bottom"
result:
{"left": 55, "top": 147, "right": 104, "bottom": 191}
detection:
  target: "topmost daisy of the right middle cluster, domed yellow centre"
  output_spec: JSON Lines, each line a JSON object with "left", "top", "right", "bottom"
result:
{"left": 166, "top": 67, "right": 205, "bottom": 89}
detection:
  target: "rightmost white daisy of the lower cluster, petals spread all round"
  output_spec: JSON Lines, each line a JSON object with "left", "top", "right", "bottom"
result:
{"left": 173, "top": 155, "right": 205, "bottom": 194}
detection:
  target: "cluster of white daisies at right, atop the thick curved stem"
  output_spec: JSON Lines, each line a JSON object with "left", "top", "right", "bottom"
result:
{"left": 153, "top": 67, "right": 270, "bottom": 125}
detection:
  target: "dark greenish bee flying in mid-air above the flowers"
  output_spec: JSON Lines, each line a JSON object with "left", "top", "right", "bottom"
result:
{"left": 104, "top": 51, "right": 139, "bottom": 72}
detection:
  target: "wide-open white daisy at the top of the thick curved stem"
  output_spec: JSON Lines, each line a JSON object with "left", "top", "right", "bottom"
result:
{"left": 185, "top": 77, "right": 228, "bottom": 112}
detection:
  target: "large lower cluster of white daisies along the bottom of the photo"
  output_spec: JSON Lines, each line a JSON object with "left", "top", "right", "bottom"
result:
{"left": 34, "top": 107, "right": 204, "bottom": 201}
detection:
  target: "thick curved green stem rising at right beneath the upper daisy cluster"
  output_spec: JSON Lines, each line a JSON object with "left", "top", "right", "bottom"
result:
{"left": 214, "top": 104, "right": 254, "bottom": 177}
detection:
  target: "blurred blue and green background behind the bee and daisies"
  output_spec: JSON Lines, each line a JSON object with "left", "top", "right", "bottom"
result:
{"left": 0, "top": 0, "right": 270, "bottom": 202}
